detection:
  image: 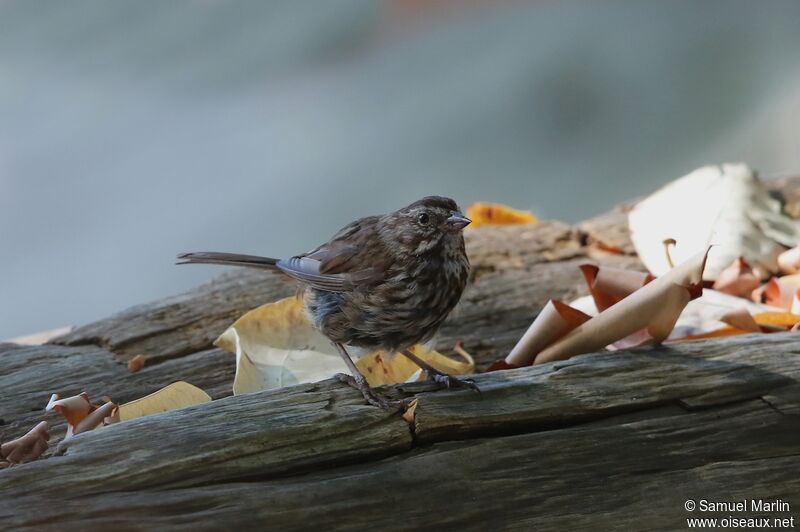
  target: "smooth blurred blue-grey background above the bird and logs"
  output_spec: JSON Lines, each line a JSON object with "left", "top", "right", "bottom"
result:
{"left": 0, "top": 0, "right": 800, "bottom": 339}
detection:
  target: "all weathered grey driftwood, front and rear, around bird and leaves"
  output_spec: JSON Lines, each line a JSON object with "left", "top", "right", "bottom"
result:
{"left": 0, "top": 181, "right": 800, "bottom": 530}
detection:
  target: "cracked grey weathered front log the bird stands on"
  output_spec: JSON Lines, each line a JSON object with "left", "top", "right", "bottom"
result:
{"left": 0, "top": 334, "right": 800, "bottom": 530}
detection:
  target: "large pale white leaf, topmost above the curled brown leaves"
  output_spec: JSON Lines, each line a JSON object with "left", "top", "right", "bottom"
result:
{"left": 628, "top": 164, "right": 800, "bottom": 280}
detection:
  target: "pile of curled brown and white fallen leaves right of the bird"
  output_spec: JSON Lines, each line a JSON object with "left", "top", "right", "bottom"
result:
{"left": 489, "top": 164, "right": 800, "bottom": 370}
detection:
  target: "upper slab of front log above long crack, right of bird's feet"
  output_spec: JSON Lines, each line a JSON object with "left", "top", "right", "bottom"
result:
{"left": 415, "top": 335, "right": 800, "bottom": 442}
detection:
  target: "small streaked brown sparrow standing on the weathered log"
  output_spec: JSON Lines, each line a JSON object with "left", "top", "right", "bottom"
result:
{"left": 178, "top": 196, "right": 475, "bottom": 408}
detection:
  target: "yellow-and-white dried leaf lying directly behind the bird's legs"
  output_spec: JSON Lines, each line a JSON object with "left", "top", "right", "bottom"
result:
{"left": 215, "top": 297, "right": 474, "bottom": 395}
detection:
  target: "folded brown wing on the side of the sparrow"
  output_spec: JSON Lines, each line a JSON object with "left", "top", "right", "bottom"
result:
{"left": 276, "top": 216, "right": 385, "bottom": 292}
